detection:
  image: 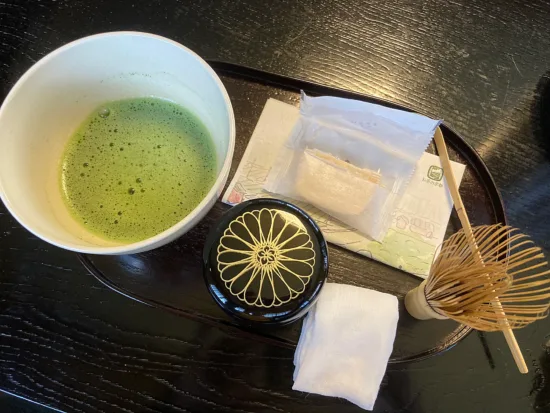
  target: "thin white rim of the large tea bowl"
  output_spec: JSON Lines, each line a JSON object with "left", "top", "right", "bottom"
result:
{"left": 0, "top": 31, "right": 235, "bottom": 255}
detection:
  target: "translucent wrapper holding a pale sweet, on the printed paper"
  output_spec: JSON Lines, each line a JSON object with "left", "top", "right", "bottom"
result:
{"left": 264, "top": 93, "right": 440, "bottom": 241}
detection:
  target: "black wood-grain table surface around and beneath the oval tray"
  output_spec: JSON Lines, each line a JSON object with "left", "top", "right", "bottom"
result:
{"left": 0, "top": 0, "right": 550, "bottom": 413}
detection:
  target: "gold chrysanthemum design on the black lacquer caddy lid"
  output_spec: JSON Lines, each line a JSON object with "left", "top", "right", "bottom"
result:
{"left": 217, "top": 208, "right": 315, "bottom": 308}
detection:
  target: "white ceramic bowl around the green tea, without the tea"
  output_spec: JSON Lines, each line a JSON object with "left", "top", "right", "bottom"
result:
{"left": 0, "top": 32, "right": 235, "bottom": 254}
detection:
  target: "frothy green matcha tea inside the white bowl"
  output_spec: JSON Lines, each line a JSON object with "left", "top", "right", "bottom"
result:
{"left": 60, "top": 97, "right": 216, "bottom": 243}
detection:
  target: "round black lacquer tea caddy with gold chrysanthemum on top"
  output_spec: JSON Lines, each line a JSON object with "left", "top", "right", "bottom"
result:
{"left": 203, "top": 199, "right": 328, "bottom": 326}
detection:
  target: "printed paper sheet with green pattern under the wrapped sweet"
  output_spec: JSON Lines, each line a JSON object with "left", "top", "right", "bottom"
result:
{"left": 222, "top": 99, "right": 465, "bottom": 278}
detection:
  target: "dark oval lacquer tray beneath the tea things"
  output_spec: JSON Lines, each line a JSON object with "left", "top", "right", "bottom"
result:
{"left": 80, "top": 62, "right": 506, "bottom": 363}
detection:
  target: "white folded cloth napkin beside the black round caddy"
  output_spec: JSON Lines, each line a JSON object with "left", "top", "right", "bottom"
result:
{"left": 292, "top": 283, "right": 399, "bottom": 410}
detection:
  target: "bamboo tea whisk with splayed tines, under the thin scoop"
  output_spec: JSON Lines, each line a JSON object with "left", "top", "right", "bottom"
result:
{"left": 406, "top": 225, "right": 550, "bottom": 331}
